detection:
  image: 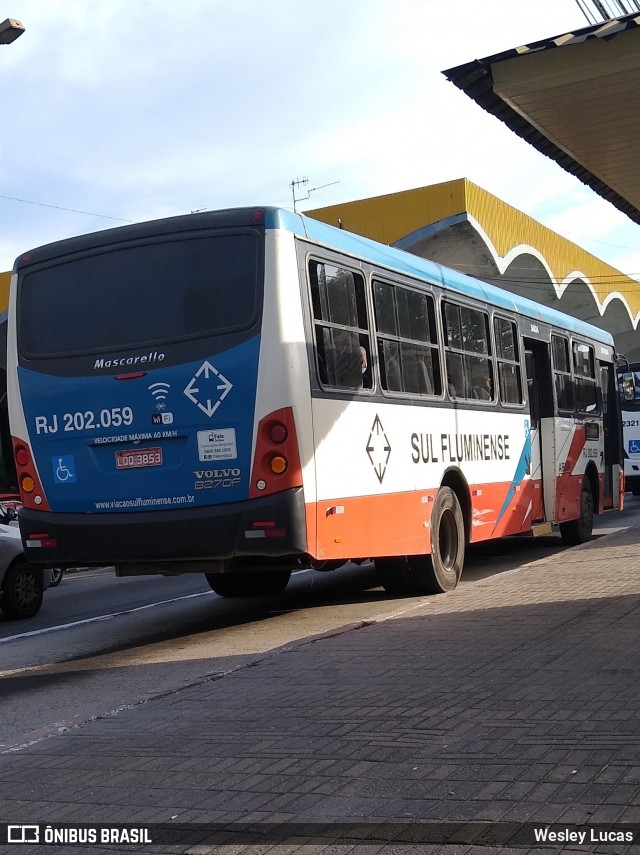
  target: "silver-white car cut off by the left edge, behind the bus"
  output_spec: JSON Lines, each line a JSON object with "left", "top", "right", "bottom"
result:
{"left": 0, "top": 508, "right": 51, "bottom": 619}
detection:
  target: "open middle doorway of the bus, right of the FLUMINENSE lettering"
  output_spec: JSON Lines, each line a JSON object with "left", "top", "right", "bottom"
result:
{"left": 524, "top": 338, "right": 556, "bottom": 523}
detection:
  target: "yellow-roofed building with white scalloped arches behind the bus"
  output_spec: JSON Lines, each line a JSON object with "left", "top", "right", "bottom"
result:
{"left": 306, "top": 178, "right": 640, "bottom": 362}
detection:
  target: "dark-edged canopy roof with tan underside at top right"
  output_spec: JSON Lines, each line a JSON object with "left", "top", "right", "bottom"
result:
{"left": 443, "top": 14, "right": 640, "bottom": 223}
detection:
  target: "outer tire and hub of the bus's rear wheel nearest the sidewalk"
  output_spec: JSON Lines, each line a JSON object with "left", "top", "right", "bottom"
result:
{"left": 411, "top": 487, "right": 465, "bottom": 594}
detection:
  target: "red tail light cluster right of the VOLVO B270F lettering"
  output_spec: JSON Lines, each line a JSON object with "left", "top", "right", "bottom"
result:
{"left": 249, "top": 407, "right": 302, "bottom": 499}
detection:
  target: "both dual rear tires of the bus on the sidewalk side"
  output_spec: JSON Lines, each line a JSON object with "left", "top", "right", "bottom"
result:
{"left": 375, "top": 487, "right": 465, "bottom": 594}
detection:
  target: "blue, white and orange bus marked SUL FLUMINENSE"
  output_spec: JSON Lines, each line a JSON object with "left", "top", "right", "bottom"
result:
{"left": 8, "top": 208, "right": 624, "bottom": 596}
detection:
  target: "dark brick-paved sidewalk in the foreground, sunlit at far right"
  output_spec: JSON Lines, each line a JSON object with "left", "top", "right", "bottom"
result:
{"left": 0, "top": 529, "right": 640, "bottom": 855}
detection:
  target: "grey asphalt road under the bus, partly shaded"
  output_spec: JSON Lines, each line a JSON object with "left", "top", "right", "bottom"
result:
{"left": 0, "top": 496, "right": 640, "bottom": 752}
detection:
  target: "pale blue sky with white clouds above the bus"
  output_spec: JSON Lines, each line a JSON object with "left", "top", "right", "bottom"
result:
{"left": 0, "top": 0, "right": 640, "bottom": 276}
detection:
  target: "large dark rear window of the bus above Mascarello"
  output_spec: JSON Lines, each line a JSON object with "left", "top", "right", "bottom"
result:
{"left": 18, "top": 233, "right": 262, "bottom": 357}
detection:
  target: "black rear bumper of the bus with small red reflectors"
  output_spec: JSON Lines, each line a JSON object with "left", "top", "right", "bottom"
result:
{"left": 18, "top": 487, "right": 307, "bottom": 573}
